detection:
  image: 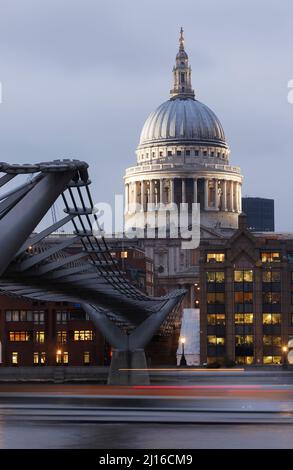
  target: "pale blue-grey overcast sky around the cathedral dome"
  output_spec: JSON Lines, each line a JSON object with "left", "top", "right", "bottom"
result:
{"left": 0, "top": 0, "right": 293, "bottom": 231}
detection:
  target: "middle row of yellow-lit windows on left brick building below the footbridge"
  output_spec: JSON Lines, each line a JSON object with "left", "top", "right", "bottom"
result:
{"left": 8, "top": 330, "right": 94, "bottom": 344}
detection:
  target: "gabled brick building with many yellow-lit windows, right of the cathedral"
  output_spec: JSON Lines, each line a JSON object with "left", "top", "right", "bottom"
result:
{"left": 200, "top": 215, "right": 293, "bottom": 365}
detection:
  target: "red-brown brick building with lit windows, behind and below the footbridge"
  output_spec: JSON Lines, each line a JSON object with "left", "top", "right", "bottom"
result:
{"left": 0, "top": 244, "right": 154, "bottom": 366}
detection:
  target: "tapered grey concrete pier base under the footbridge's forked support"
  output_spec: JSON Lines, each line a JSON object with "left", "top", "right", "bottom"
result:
{"left": 108, "top": 349, "right": 150, "bottom": 385}
